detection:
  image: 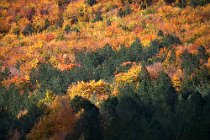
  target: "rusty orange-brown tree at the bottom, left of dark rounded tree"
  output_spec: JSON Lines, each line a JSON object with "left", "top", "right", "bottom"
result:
{"left": 27, "top": 97, "right": 77, "bottom": 139}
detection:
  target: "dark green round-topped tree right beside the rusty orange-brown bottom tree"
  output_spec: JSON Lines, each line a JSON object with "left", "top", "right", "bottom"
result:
{"left": 66, "top": 96, "right": 103, "bottom": 140}
